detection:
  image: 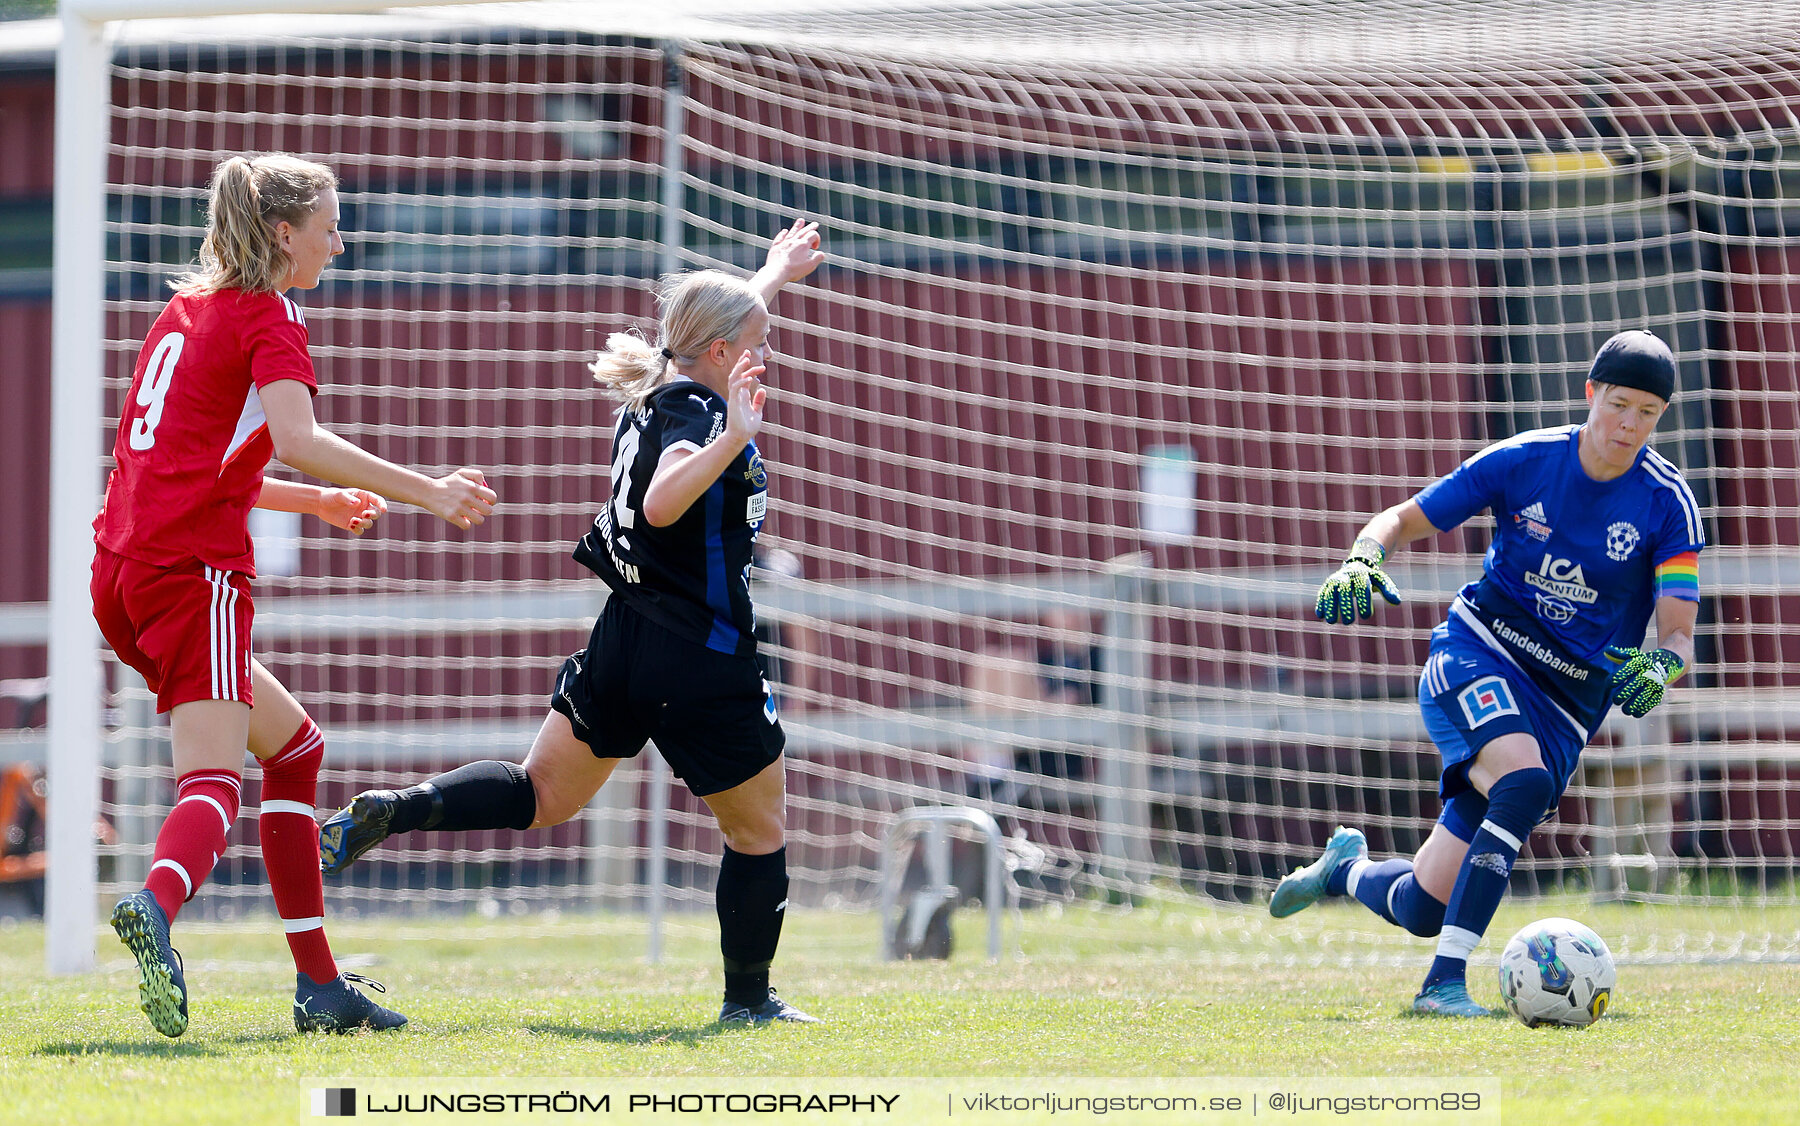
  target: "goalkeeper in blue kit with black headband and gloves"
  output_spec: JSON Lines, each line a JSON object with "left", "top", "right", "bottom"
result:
{"left": 1269, "top": 331, "right": 1705, "bottom": 1016}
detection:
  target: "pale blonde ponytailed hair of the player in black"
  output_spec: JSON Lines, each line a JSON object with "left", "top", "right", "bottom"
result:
{"left": 589, "top": 270, "right": 763, "bottom": 410}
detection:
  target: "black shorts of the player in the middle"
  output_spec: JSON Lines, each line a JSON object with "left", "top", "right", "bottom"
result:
{"left": 551, "top": 595, "right": 787, "bottom": 797}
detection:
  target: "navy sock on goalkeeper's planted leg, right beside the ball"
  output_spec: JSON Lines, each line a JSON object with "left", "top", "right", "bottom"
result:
{"left": 1424, "top": 766, "right": 1555, "bottom": 989}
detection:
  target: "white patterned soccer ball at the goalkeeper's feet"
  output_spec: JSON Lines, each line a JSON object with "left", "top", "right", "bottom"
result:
{"left": 1499, "top": 919, "right": 1618, "bottom": 1029}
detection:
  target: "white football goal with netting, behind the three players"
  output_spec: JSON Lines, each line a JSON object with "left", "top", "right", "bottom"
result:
{"left": 47, "top": 0, "right": 1800, "bottom": 973}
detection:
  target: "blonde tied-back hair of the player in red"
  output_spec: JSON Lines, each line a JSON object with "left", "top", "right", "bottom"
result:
{"left": 171, "top": 153, "right": 337, "bottom": 293}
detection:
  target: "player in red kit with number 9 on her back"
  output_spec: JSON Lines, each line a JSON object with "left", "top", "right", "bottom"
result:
{"left": 92, "top": 155, "right": 495, "bottom": 1036}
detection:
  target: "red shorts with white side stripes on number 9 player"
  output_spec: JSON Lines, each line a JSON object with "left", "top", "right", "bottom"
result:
{"left": 90, "top": 547, "right": 254, "bottom": 712}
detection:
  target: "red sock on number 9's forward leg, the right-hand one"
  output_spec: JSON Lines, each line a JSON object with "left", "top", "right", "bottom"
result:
{"left": 256, "top": 719, "right": 337, "bottom": 984}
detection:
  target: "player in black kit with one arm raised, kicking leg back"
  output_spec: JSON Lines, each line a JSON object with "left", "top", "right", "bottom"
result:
{"left": 319, "top": 221, "right": 824, "bottom": 1023}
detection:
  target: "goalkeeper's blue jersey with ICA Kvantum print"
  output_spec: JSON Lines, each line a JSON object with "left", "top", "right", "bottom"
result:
{"left": 1417, "top": 426, "right": 1706, "bottom": 732}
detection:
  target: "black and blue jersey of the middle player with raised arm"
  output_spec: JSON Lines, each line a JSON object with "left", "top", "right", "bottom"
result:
{"left": 574, "top": 380, "right": 769, "bottom": 657}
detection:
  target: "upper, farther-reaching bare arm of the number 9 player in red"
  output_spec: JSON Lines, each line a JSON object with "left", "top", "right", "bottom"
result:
{"left": 259, "top": 380, "right": 495, "bottom": 529}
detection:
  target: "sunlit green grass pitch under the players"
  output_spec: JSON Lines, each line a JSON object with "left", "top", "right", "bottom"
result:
{"left": 0, "top": 901, "right": 1800, "bottom": 1126}
